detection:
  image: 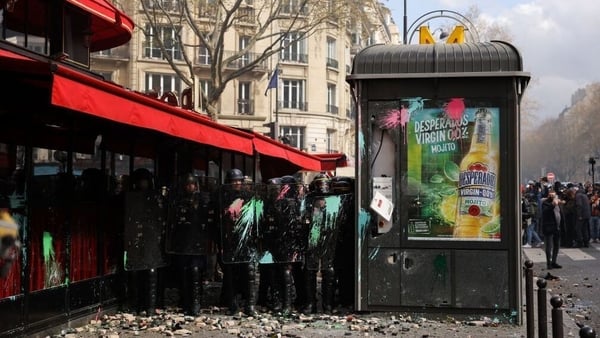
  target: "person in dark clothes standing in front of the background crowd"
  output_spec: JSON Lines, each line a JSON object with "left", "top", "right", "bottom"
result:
{"left": 542, "top": 189, "right": 565, "bottom": 269}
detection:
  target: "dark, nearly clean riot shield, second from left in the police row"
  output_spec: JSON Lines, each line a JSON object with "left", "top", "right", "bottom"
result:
{"left": 166, "top": 176, "right": 218, "bottom": 255}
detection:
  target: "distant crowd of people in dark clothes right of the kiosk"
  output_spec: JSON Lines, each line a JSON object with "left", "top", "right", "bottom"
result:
{"left": 521, "top": 177, "right": 600, "bottom": 269}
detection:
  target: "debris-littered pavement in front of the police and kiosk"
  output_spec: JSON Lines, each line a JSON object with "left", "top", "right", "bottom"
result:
{"left": 43, "top": 270, "right": 592, "bottom": 338}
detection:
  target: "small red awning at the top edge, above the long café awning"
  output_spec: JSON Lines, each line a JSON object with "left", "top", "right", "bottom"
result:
{"left": 67, "top": 0, "right": 134, "bottom": 52}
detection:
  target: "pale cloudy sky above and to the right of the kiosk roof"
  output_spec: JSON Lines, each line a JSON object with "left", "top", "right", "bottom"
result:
{"left": 382, "top": 0, "right": 600, "bottom": 119}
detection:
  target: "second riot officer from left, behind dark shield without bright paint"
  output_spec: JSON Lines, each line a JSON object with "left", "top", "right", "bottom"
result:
{"left": 167, "top": 173, "right": 216, "bottom": 316}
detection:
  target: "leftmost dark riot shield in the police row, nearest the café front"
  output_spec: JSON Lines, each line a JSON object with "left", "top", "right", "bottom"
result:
{"left": 124, "top": 190, "right": 168, "bottom": 271}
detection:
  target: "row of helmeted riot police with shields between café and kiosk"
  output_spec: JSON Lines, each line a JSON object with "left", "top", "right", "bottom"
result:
{"left": 123, "top": 169, "right": 354, "bottom": 316}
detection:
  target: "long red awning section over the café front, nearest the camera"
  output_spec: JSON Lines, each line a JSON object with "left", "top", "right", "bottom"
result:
{"left": 51, "top": 65, "right": 254, "bottom": 155}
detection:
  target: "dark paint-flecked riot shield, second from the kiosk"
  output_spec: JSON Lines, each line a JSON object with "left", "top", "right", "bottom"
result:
{"left": 259, "top": 183, "right": 310, "bottom": 264}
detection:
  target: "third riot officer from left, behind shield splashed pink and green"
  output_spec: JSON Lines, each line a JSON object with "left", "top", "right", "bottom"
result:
{"left": 220, "top": 169, "right": 257, "bottom": 316}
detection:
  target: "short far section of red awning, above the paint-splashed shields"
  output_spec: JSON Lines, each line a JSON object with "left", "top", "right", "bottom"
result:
{"left": 252, "top": 133, "right": 322, "bottom": 171}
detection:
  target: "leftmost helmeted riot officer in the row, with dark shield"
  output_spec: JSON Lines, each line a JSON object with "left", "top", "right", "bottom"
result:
{"left": 124, "top": 168, "right": 168, "bottom": 315}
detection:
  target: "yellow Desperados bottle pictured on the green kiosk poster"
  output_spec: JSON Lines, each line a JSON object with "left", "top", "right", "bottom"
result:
{"left": 453, "top": 108, "right": 498, "bottom": 238}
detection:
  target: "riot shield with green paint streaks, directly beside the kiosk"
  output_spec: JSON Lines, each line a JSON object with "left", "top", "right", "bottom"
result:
{"left": 306, "top": 194, "right": 353, "bottom": 270}
